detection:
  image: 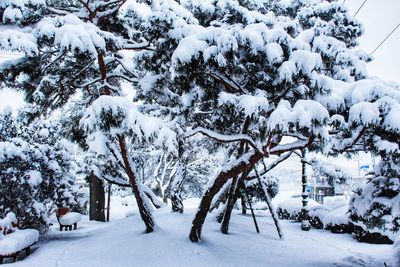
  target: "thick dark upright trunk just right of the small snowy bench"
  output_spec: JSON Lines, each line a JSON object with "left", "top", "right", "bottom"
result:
{"left": 89, "top": 173, "right": 106, "bottom": 222}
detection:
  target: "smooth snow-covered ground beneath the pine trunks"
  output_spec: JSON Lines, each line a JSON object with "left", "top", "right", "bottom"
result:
{"left": 7, "top": 190, "right": 395, "bottom": 267}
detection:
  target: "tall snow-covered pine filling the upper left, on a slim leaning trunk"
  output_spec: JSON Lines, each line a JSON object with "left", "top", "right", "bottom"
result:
{"left": 0, "top": 0, "right": 178, "bottom": 232}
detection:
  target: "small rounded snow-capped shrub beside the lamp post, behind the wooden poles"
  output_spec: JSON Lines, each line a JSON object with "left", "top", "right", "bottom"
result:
{"left": 276, "top": 196, "right": 320, "bottom": 221}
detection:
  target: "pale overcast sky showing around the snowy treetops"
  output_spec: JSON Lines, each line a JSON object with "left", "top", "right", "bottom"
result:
{"left": 0, "top": 0, "right": 400, "bottom": 109}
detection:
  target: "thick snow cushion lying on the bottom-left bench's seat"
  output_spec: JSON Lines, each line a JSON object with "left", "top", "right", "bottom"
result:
{"left": 0, "top": 229, "right": 39, "bottom": 255}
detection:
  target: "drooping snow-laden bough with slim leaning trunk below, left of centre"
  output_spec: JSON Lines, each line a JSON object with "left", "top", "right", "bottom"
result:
{"left": 81, "top": 96, "right": 177, "bottom": 232}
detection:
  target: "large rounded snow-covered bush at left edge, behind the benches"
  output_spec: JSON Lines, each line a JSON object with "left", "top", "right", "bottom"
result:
{"left": 0, "top": 113, "right": 86, "bottom": 232}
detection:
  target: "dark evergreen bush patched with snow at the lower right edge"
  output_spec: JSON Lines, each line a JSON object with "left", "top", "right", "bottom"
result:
{"left": 350, "top": 159, "right": 400, "bottom": 243}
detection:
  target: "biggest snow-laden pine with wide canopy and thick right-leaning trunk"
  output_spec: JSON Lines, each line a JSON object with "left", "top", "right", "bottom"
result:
{"left": 130, "top": 0, "right": 399, "bottom": 242}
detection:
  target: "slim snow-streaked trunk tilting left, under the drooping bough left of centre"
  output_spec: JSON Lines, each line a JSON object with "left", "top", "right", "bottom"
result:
{"left": 118, "top": 136, "right": 154, "bottom": 233}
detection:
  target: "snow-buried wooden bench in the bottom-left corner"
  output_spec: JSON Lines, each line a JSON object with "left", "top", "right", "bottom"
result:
{"left": 0, "top": 212, "right": 39, "bottom": 264}
